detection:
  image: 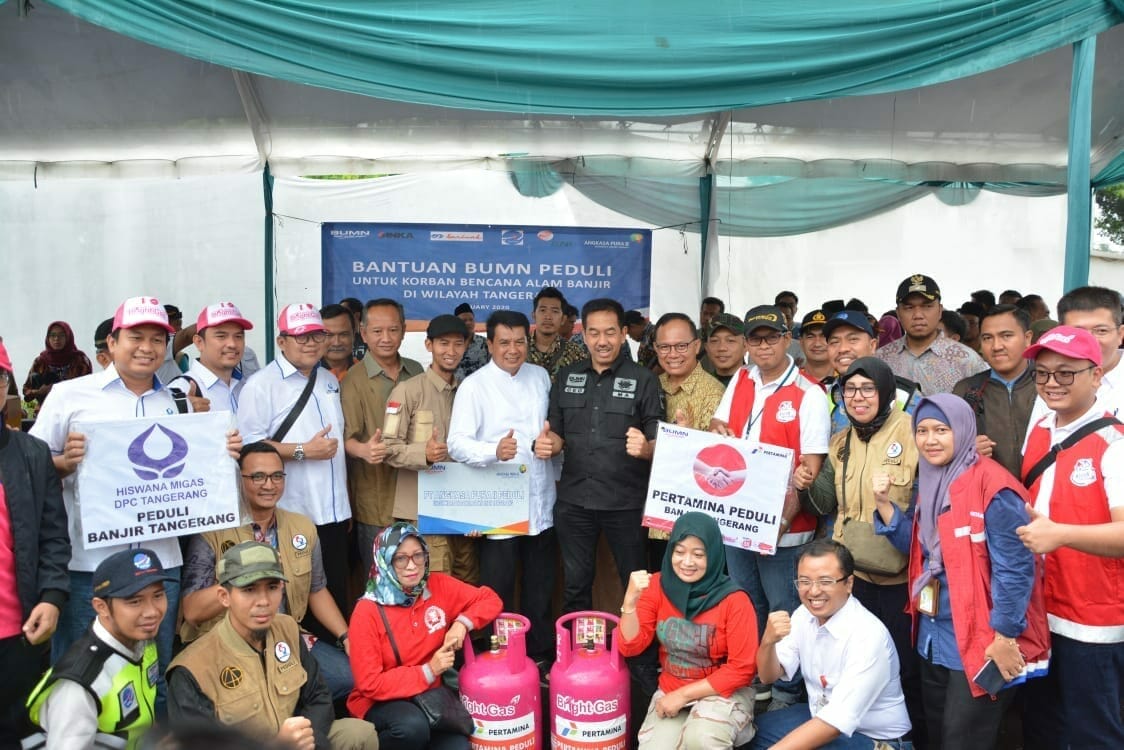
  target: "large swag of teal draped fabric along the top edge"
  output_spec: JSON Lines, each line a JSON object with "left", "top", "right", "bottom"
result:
{"left": 52, "top": 0, "right": 1120, "bottom": 117}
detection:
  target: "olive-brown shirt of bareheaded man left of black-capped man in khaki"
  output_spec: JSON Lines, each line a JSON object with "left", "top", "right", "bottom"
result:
{"left": 339, "top": 352, "right": 422, "bottom": 526}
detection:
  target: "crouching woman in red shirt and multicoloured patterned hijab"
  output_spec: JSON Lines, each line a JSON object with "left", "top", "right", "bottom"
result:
{"left": 347, "top": 522, "right": 504, "bottom": 750}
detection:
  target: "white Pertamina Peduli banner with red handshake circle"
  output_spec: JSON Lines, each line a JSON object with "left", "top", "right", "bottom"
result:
{"left": 644, "top": 422, "right": 792, "bottom": 554}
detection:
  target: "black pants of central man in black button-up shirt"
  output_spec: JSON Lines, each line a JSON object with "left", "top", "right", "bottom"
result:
{"left": 554, "top": 503, "right": 647, "bottom": 614}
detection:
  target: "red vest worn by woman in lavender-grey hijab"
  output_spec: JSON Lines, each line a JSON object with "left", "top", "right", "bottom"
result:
{"left": 909, "top": 455, "right": 1050, "bottom": 697}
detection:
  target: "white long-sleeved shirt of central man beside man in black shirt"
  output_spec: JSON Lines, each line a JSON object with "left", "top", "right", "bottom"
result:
{"left": 448, "top": 361, "right": 555, "bottom": 539}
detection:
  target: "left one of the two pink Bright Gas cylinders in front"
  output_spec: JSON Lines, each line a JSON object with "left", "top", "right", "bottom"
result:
{"left": 460, "top": 612, "right": 543, "bottom": 750}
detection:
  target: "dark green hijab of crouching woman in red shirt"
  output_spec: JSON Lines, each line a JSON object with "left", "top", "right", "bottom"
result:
{"left": 660, "top": 510, "right": 738, "bottom": 620}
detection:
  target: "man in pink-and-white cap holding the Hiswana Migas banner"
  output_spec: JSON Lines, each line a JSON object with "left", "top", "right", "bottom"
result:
{"left": 30, "top": 297, "right": 242, "bottom": 679}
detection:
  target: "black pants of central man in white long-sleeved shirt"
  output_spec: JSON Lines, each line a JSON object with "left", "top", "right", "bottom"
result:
{"left": 480, "top": 528, "right": 559, "bottom": 661}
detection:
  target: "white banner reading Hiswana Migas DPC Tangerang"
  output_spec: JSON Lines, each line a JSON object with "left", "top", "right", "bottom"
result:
{"left": 74, "top": 412, "right": 239, "bottom": 550}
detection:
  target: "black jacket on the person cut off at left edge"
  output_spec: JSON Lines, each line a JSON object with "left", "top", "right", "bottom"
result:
{"left": 0, "top": 423, "right": 71, "bottom": 618}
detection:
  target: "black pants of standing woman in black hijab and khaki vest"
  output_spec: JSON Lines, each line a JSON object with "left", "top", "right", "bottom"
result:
{"left": 851, "top": 576, "right": 926, "bottom": 750}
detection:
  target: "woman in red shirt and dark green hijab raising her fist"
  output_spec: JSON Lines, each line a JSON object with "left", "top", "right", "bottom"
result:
{"left": 620, "top": 512, "right": 758, "bottom": 749}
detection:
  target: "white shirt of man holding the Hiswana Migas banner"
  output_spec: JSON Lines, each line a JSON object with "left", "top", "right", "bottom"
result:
{"left": 30, "top": 364, "right": 183, "bottom": 572}
